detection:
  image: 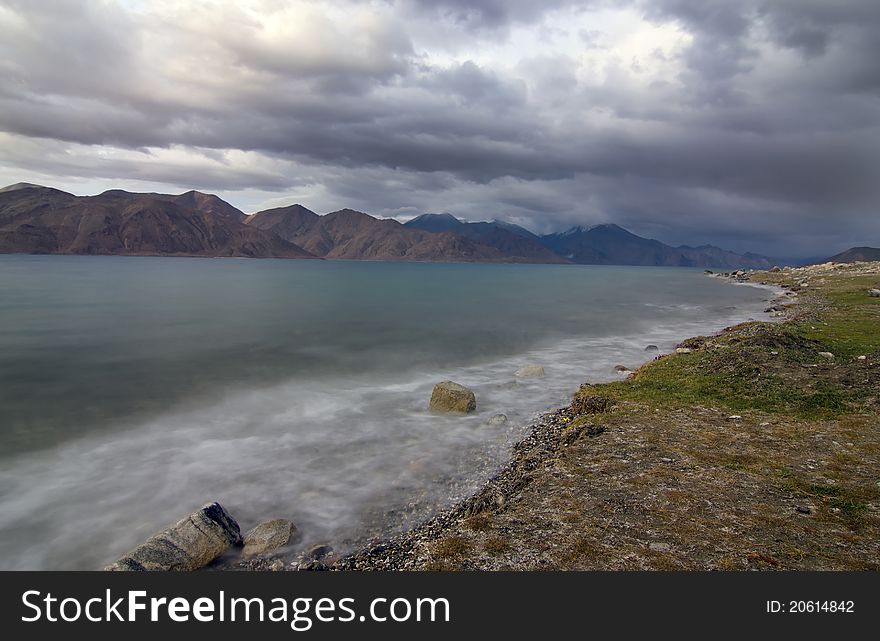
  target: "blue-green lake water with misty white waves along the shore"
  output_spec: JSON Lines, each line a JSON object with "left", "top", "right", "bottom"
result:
{"left": 0, "top": 256, "right": 769, "bottom": 569}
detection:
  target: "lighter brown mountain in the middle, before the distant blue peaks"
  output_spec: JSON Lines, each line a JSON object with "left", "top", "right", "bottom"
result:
{"left": 248, "top": 205, "right": 544, "bottom": 262}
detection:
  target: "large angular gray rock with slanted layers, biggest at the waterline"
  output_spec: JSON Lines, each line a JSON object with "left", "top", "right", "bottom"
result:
{"left": 104, "top": 503, "right": 241, "bottom": 571}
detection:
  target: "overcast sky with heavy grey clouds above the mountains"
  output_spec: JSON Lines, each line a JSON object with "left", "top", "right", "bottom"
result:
{"left": 0, "top": 0, "right": 880, "bottom": 257}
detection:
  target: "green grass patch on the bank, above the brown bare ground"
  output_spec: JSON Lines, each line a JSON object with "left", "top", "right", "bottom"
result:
{"left": 572, "top": 274, "right": 880, "bottom": 419}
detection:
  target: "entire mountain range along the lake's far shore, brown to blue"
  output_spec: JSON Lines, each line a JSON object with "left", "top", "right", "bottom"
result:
{"left": 0, "top": 183, "right": 796, "bottom": 269}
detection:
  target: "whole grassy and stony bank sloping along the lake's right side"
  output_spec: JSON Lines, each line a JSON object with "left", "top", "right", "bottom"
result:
{"left": 343, "top": 263, "right": 880, "bottom": 570}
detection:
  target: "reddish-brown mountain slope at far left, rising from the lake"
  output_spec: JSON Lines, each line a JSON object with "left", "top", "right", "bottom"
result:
{"left": 0, "top": 186, "right": 314, "bottom": 258}
